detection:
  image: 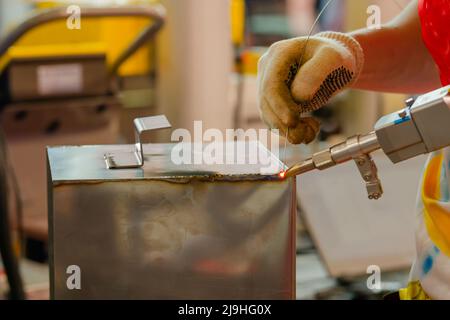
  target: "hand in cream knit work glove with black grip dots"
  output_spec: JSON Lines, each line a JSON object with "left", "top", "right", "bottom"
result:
{"left": 258, "top": 32, "right": 364, "bottom": 144}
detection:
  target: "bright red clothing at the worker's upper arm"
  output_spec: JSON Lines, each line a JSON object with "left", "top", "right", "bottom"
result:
{"left": 419, "top": 0, "right": 450, "bottom": 86}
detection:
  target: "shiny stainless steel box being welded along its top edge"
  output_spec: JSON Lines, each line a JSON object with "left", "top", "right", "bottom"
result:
{"left": 47, "top": 142, "right": 296, "bottom": 299}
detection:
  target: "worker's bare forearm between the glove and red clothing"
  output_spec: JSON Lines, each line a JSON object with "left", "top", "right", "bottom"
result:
{"left": 351, "top": 0, "right": 440, "bottom": 93}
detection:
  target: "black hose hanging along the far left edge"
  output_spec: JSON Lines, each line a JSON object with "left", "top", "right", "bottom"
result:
{"left": 0, "top": 130, "right": 25, "bottom": 300}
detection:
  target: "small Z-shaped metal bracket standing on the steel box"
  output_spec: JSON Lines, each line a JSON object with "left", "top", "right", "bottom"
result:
{"left": 104, "top": 115, "right": 172, "bottom": 169}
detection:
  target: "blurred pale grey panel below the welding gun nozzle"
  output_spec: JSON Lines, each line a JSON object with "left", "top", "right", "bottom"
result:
{"left": 297, "top": 154, "right": 426, "bottom": 276}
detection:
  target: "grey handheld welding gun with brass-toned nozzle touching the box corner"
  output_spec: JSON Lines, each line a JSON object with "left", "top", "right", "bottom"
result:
{"left": 284, "top": 86, "right": 450, "bottom": 199}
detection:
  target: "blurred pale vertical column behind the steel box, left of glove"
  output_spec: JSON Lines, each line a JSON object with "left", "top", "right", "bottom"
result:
{"left": 158, "top": 0, "right": 233, "bottom": 136}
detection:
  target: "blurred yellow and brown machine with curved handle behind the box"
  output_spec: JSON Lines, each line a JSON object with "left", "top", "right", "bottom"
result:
{"left": 0, "top": 3, "right": 165, "bottom": 260}
